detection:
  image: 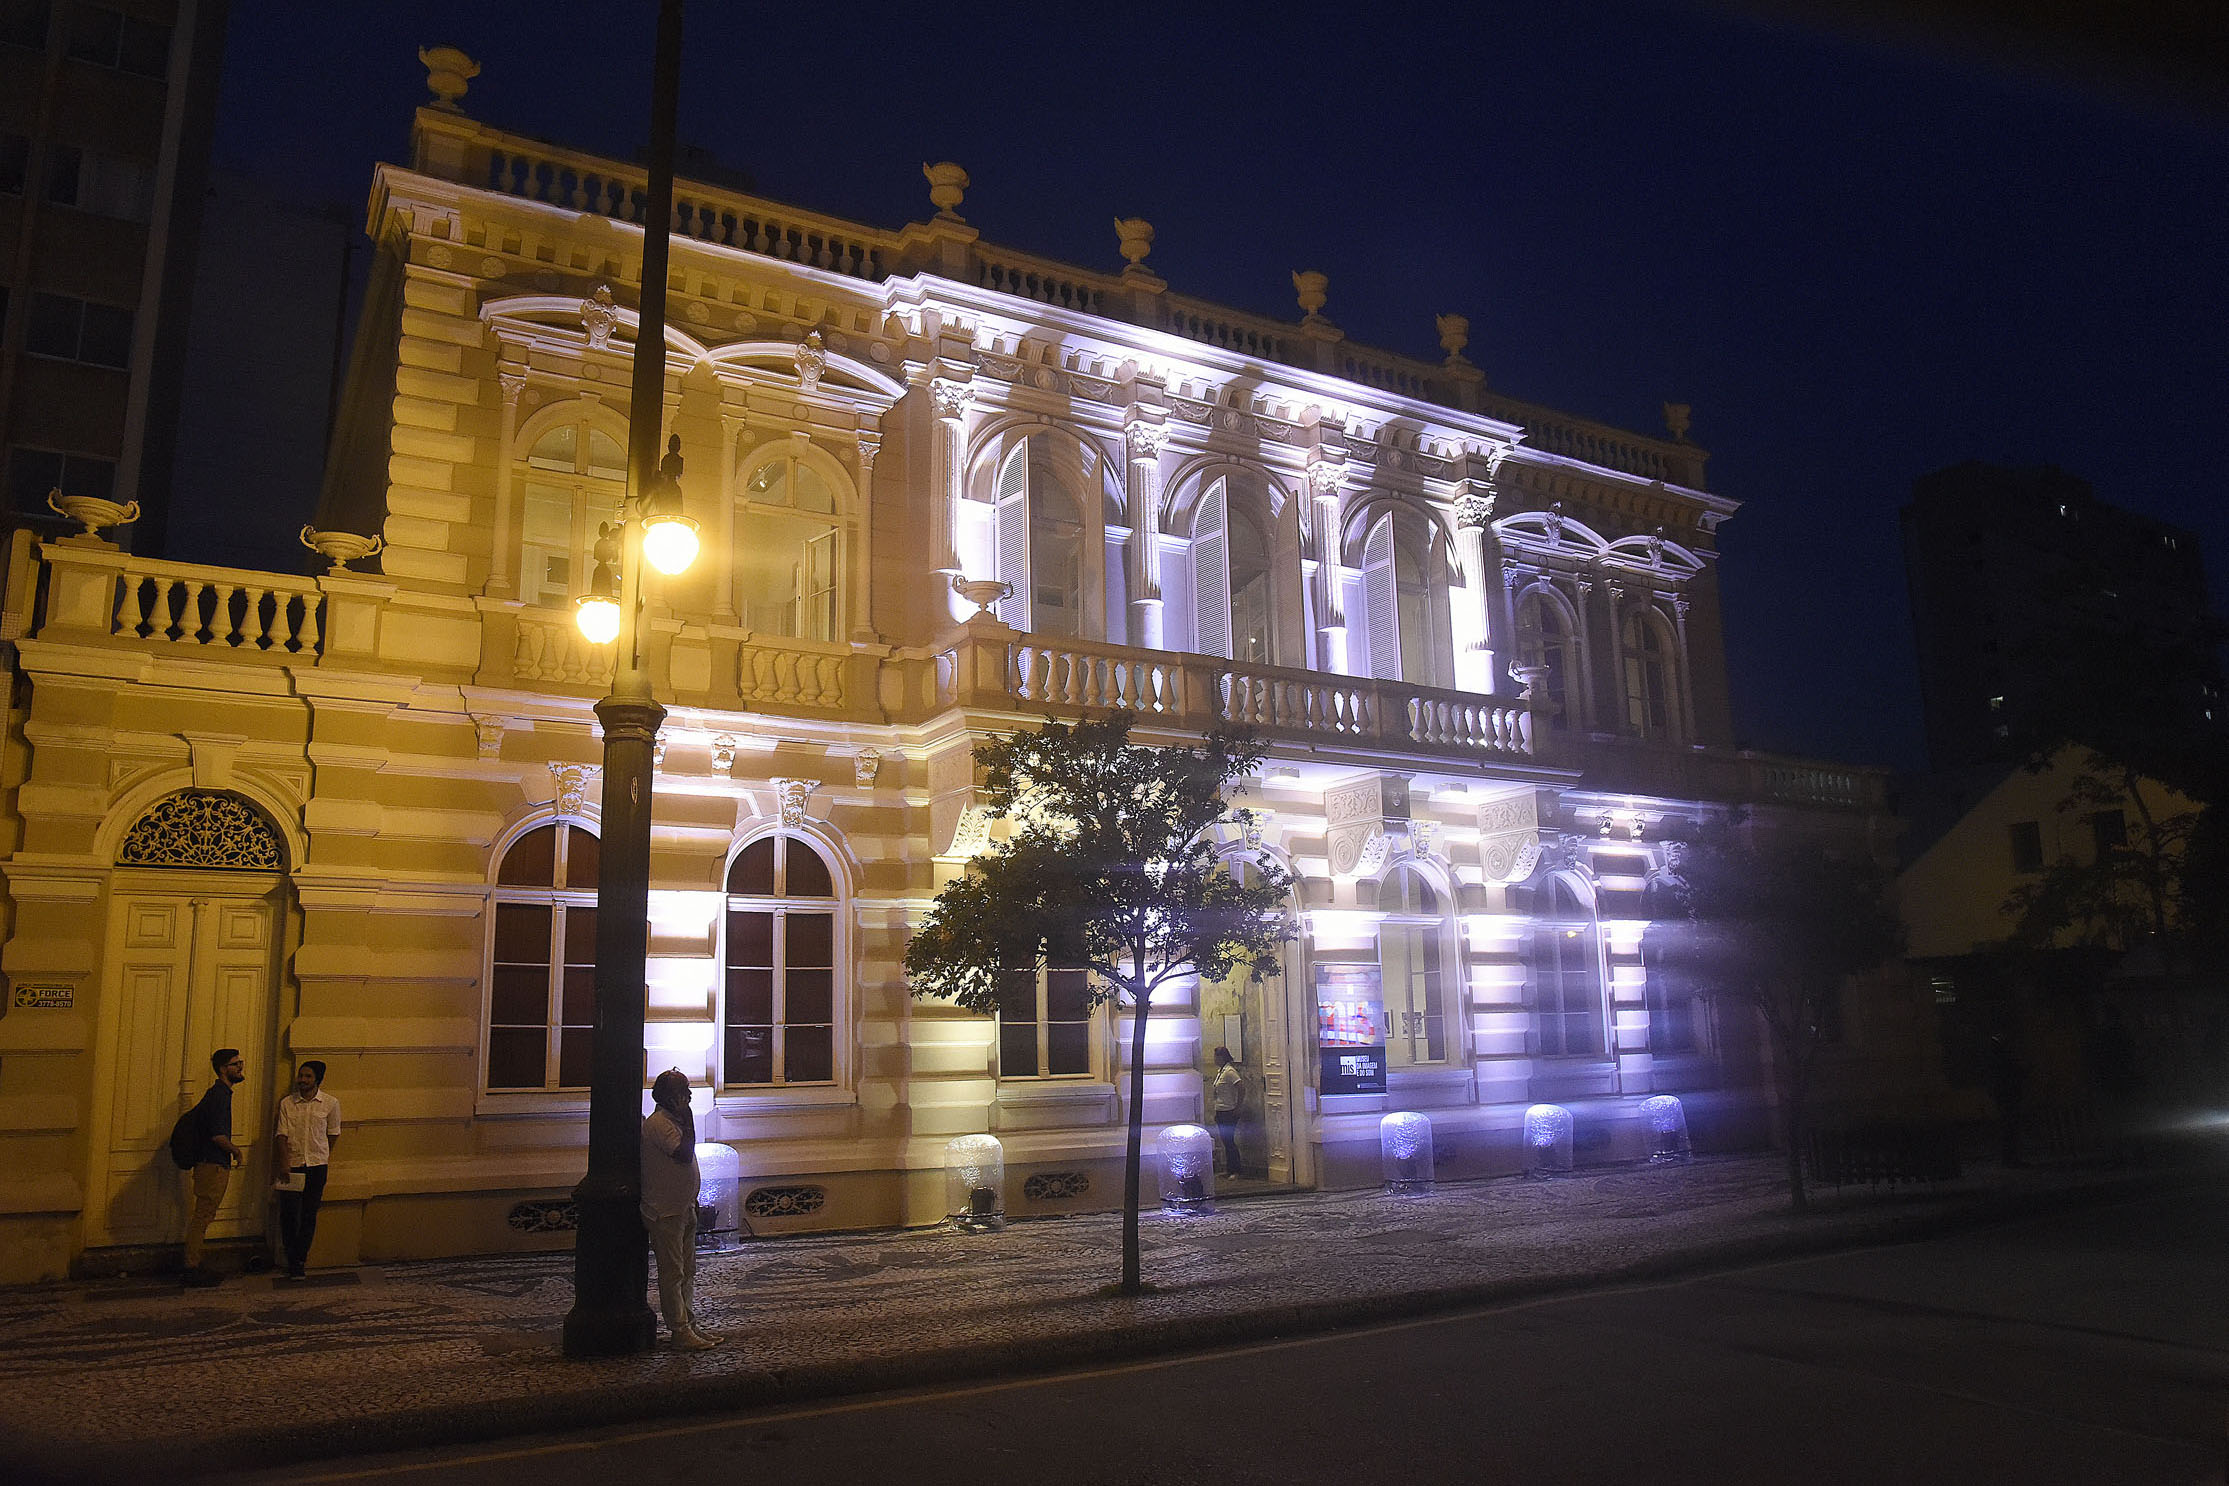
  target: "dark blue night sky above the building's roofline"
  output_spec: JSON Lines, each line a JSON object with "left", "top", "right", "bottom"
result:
{"left": 200, "top": 0, "right": 2229, "bottom": 764}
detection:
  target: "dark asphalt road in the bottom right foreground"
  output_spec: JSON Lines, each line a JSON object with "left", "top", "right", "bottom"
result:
{"left": 256, "top": 1192, "right": 2229, "bottom": 1486}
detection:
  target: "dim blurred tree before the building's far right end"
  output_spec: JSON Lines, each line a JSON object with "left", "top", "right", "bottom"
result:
{"left": 1656, "top": 822, "right": 1904, "bottom": 1212}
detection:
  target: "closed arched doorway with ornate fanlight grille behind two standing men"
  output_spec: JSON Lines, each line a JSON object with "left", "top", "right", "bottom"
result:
{"left": 85, "top": 789, "right": 285, "bottom": 1248}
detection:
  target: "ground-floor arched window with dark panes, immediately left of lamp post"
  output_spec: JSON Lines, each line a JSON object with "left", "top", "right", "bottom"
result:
{"left": 486, "top": 822, "right": 597, "bottom": 1094}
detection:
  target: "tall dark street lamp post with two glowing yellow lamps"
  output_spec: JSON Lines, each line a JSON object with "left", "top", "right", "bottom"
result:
{"left": 564, "top": 0, "right": 695, "bottom": 1357}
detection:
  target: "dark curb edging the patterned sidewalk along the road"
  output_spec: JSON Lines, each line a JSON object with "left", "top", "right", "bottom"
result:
{"left": 13, "top": 1167, "right": 2216, "bottom": 1486}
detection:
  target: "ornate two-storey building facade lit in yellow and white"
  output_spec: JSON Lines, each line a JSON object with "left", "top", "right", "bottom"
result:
{"left": 0, "top": 53, "right": 1879, "bottom": 1277}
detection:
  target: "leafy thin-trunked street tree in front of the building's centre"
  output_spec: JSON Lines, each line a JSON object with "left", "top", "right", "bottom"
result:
{"left": 905, "top": 711, "right": 1293, "bottom": 1294}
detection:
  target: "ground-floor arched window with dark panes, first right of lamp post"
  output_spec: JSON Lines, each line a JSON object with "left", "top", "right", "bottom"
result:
{"left": 720, "top": 835, "right": 838, "bottom": 1087}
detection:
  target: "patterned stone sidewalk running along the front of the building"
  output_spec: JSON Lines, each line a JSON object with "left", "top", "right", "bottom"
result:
{"left": 0, "top": 1156, "right": 2175, "bottom": 1479}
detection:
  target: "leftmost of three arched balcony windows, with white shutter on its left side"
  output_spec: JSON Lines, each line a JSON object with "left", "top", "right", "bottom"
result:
{"left": 994, "top": 432, "right": 1092, "bottom": 637}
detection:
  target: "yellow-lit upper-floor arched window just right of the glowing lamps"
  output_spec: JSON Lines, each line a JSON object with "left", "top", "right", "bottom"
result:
{"left": 736, "top": 450, "right": 843, "bottom": 639}
